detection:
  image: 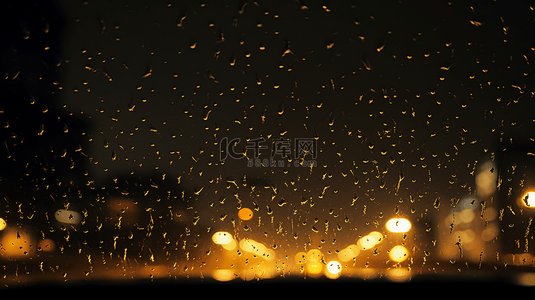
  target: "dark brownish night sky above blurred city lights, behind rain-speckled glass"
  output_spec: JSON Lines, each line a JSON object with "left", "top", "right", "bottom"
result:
{"left": 53, "top": 1, "right": 533, "bottom": 195}
